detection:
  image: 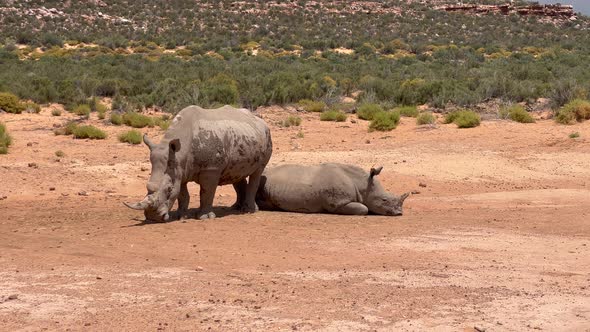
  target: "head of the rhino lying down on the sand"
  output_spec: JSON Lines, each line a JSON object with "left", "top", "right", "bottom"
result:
{"left": 365, "top": 166, "right": 410, "bottom": 216}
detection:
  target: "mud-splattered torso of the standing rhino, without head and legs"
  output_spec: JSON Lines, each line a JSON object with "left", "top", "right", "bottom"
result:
{"left": 165, "top": 106, "right": 272, "bottom": 185}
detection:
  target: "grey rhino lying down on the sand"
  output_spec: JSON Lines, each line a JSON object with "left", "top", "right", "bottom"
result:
{"left": 256, "top": 163, "right": 409, "bottom": 216}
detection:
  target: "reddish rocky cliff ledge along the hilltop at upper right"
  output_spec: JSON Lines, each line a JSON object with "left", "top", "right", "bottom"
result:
{"left": 437, "top": 4, "right": 576, "bottom": 20}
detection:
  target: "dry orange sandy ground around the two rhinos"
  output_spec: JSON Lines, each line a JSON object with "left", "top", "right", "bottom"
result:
{"left": 0, "top": 109, "right": 590, "bottom": 331}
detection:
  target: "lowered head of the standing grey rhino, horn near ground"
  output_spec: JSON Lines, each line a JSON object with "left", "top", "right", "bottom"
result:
{"left": 124, "top": 135, "right": 181, "bottom": 221}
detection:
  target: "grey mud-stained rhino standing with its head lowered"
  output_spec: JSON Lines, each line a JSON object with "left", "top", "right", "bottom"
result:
{"left": 125, "top": 105, "right": 272, "bottom": 221}
